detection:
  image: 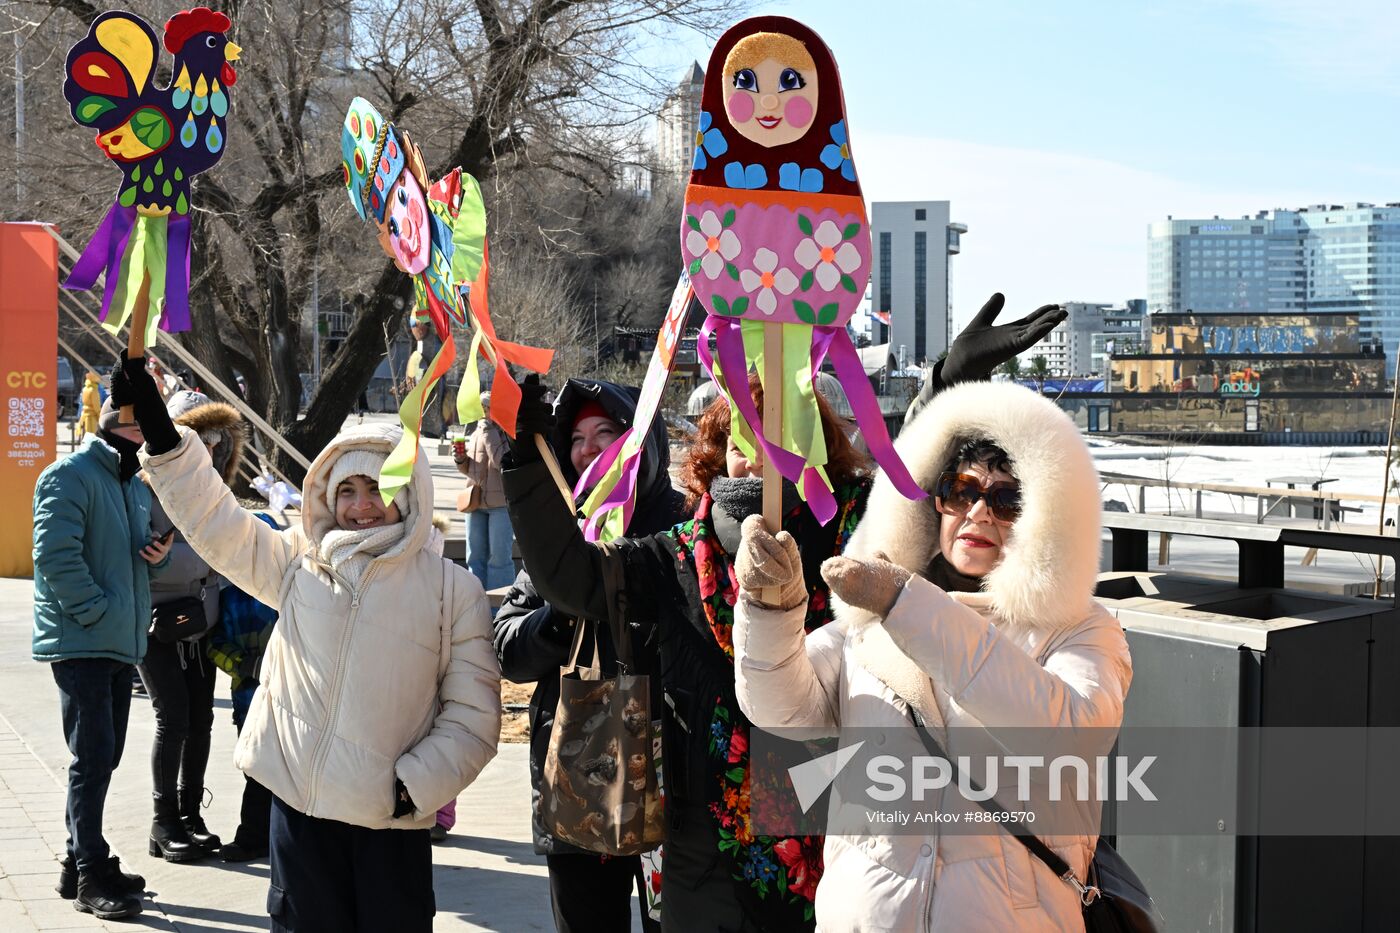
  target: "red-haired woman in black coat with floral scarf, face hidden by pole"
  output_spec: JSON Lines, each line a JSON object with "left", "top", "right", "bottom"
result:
{"left": 503, "top": 380, "right": 869, "bottom": 932}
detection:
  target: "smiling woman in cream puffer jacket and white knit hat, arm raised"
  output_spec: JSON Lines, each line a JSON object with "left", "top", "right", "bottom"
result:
{"left": 119, "top": 360, "right": 501, "bottom": 932}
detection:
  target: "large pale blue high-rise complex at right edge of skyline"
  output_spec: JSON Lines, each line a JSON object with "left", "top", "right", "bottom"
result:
{"left": 1147, "top": 203, "right": 1400, "bottom": 373}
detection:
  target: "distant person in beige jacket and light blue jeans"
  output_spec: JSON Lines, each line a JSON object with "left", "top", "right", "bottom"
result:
{"left": 452, "top": 392, "right": 515, "bottom": 590}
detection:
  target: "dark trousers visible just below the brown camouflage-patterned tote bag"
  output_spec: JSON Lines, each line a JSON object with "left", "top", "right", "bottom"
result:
{"left": 545, "top": 853, "right": 665, "bottom": 933}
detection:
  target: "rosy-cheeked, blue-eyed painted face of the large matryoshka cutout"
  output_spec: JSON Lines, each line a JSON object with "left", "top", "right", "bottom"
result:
{"left": 724, "top": 32, "right": 819, "bottom": 147}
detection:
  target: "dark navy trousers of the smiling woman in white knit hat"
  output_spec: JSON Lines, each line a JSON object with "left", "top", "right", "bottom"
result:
{"left": 267, "top": 797, "right": 437, "bottom": 933}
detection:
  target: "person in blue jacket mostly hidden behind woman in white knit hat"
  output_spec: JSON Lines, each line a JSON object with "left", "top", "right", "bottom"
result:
{"left": 209, "top": 511, "right": 277, "bottom": 862}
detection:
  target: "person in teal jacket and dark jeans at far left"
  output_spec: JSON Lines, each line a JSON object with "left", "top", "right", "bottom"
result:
{"left": 34, "top": 389, "right": 171, "bottom": 919}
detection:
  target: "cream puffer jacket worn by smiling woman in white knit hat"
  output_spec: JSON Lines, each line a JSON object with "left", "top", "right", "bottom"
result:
{"left": 143, "top": 424, "right": 501, "bottom": 829}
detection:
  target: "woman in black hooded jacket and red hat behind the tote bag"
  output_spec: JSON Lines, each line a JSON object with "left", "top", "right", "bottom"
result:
{"left": 494, "top": 380, "right": 686, "bottom": 933}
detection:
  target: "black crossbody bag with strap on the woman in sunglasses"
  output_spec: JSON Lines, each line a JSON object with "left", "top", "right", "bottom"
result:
{"left": 906, "top": 703, "right": 1166, "bottom": 933}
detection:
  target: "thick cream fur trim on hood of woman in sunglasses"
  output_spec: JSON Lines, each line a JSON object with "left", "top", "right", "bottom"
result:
{"left": 840, "top": 382, "right": 1102, "bottom": 630}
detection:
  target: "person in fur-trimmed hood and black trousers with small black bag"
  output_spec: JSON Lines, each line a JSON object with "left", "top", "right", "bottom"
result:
{"left": 139, "top": 389, "right": 245, "bottom": 863}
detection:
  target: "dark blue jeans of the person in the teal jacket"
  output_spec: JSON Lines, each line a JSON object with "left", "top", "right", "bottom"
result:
{"left": 50, "top": 657, "right": 132, "bottom": 871}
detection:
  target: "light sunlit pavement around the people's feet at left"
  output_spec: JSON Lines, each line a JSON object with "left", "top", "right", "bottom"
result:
{"left": 0, "top": 417, "right": 585, "bottom": 933}
